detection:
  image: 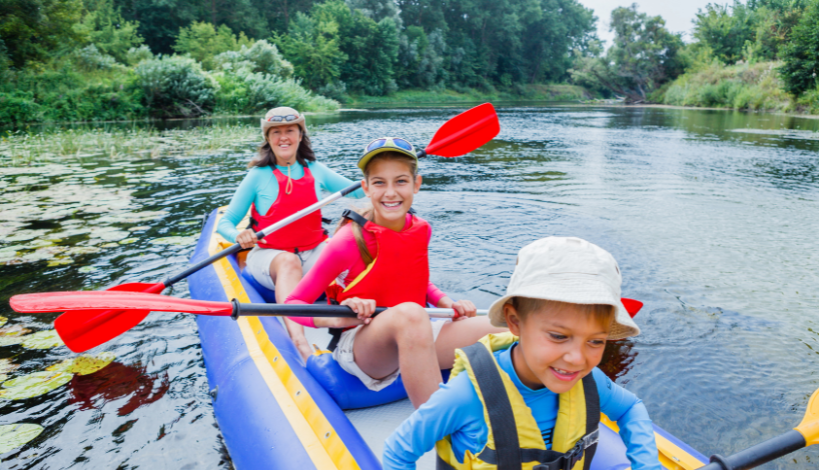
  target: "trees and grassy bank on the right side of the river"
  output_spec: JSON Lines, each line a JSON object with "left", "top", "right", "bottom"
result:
{"left": 571, "top": 0, "right": 819, "bottom": 112}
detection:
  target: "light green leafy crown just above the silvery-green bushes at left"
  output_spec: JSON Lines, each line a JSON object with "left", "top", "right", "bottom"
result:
{"left": 173, "top": 22, "right": 252, "bottom": 70}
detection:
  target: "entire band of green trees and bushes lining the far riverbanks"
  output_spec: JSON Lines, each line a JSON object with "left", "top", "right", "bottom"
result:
{"left": 0, "top": 0, "right": 819, "bottom": 123}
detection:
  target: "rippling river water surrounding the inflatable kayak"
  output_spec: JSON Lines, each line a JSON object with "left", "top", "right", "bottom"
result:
{"left": 0, "top": 104, "right": 819, "bottom": 469}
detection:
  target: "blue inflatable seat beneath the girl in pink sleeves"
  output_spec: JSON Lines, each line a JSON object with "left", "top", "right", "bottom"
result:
{"left": 307, "top": 350, "right": 449, "bottom": 410}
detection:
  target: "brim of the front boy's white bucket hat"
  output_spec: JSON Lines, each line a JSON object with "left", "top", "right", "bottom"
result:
{"left": 489, "top": 280, "right": 640, "bottom": 340}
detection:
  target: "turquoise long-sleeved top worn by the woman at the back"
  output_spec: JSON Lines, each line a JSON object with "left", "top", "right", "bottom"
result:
{"left": 216, "top": 161, "right": 364, "bottom": 243}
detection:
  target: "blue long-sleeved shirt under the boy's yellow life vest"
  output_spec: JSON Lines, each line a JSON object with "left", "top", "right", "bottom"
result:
{"left": 382, "top": 343, "right": 662, "bottom": 470}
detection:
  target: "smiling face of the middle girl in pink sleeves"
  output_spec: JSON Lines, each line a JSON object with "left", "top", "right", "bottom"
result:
{"left": 361, "top": 157, "right": 421, "bottom": 232}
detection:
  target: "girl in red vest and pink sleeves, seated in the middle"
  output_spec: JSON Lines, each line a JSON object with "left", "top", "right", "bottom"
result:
{"left": 285, "top": 137, "right": 503, "bottom": 408}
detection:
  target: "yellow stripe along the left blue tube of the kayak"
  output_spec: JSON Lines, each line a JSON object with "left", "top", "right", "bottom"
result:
{"left": 208, "top": 208, "right": 360, "bottom": 469}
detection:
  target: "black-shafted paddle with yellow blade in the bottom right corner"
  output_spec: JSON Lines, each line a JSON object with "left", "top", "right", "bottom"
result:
{"left": 700, "top": 389, "right": 819, "bottom": 470}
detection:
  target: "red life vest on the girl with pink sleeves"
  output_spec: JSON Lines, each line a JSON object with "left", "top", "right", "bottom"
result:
{"left": 327, "top": 215, "right": 431, "bottom": 307}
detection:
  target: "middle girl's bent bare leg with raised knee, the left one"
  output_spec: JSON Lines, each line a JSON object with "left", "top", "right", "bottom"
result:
{"left": 353, "top": 303, "right": 443, "bottom": 408}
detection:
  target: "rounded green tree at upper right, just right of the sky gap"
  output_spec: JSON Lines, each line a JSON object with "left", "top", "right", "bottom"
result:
{"left": 693, "top": 0, "right": 754, "bottom": 64}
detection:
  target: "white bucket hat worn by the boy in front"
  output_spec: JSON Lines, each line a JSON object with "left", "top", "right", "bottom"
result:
{"left": 489, "top": 237, "right": 640, "bottom": 339}
